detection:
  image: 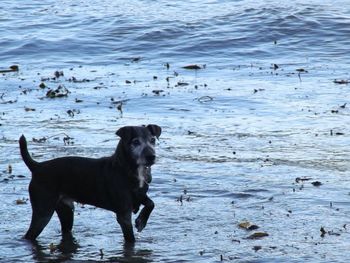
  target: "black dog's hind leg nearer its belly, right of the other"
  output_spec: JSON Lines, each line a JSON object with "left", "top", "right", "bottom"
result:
{"left": 55, "top": 198, "right": 74, "bottom": 235}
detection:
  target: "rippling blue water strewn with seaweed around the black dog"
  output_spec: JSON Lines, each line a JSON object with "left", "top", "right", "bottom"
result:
{"left": 0, "top": 0, "right": 350, "bottom": 262}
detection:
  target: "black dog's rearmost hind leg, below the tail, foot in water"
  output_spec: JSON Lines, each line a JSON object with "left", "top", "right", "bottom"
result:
{"left": 24, "top": 183, "right": 57, "bottom": 240}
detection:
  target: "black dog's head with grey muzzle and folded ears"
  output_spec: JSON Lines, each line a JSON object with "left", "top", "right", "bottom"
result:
{"left": 116, "top": 124, "right": 162, "bottom": 187}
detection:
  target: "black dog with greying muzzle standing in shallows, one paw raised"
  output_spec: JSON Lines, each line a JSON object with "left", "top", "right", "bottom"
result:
{"left": 19, "top": 124, "right": 161, "bottom": 243}
